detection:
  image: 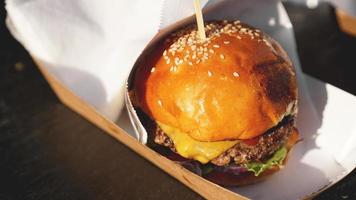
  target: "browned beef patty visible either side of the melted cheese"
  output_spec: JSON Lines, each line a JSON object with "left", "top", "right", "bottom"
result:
{"left": 154, "top": 116, "right": 294, "bottom": 166}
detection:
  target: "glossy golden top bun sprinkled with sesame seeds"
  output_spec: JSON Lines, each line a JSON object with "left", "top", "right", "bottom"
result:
{"left": 139, "top": 21, "right": 297, "bottom": 141}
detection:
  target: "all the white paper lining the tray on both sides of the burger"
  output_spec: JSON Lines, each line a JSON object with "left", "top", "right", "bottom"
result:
{"left": 6, "top": 0, "right": 356, "bottom": 199}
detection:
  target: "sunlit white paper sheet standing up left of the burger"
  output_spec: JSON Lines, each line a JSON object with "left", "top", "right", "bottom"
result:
{"left": 6, "top": 0, "right": 167, "bottom": 120}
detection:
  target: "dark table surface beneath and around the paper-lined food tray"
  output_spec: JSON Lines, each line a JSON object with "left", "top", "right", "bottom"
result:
{"left": 0, "top": 1, "right": 356, "bottom": 200}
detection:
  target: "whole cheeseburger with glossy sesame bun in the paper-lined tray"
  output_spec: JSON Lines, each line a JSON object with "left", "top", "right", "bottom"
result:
{"left": 129, "top": 21, "right": 298, "bottom": 186}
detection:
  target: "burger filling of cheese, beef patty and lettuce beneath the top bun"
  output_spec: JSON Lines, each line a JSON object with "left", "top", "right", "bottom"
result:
{"left": 154, "top": 116, "right": 294, "bottom": 175}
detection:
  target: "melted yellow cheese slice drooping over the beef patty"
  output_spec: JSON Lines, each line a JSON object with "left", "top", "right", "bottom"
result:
{"left": 158, "top": 122, "right": 238, "bottom": 164}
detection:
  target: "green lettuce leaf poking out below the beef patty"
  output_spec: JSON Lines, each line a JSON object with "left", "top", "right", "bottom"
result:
{"left": 245, "top": 147, "right": 287, "bottom": 176}
